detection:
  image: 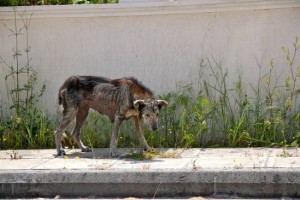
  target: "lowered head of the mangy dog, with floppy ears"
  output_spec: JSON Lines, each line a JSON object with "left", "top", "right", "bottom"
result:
{"left": 133, "top": 100, "right": 168, "bottom": 131}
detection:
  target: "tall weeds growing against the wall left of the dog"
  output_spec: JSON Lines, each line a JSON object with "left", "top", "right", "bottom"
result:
{"left": 0, "top": 8, "right": 53, "bottom": 148}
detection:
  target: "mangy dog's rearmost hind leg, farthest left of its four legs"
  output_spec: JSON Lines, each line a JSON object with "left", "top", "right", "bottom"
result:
{"left": 54, "top": 109, "right": 76, "bottom": 156}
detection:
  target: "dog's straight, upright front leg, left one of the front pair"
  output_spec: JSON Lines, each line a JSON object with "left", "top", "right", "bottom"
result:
{"left": 110, "top": 115, "right": 124, "bottom": 157}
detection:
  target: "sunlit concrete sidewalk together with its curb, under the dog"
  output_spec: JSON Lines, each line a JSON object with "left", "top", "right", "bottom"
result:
{"left": 0, "top": 148, "right": 300, "bottom": 198}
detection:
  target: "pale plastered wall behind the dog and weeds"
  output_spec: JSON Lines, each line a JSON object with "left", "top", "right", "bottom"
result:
{"left": 0, "top": 0, "right": 300, "bottom": 113}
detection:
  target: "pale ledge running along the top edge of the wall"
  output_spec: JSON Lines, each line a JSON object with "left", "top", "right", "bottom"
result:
{"left": 0, "top": 0, "right": 300, "bottom": 20}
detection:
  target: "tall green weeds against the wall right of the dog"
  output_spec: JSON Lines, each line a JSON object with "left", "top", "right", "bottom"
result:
{"left": 155, "top": 37, "right": 300, "bottom": 148}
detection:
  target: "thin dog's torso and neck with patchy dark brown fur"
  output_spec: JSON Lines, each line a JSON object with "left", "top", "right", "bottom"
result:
{"left": 58, "top": 76, "right": 154, "bottom": 113}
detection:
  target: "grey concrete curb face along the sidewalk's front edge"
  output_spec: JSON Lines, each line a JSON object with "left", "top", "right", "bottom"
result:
{"left": 0, "top": 169, "right": 300, "bottom": 198}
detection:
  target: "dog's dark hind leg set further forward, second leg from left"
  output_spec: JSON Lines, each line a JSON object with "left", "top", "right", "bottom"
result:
{"left": 72, "top": 104, "right": 92, "bottom": 152}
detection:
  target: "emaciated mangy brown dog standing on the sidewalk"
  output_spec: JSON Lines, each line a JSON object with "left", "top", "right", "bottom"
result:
{"left": 55, "top": 76, "right": 168, "bottom": 157}
